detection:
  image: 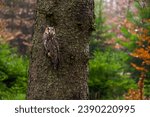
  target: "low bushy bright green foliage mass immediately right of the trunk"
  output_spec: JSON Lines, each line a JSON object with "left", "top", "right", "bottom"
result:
{"left": 88, "top": 48, "right": 136, "bottom": 99}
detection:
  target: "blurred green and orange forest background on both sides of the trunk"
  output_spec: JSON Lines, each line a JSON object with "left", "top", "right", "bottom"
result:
{"left": 0, "top": 0, "right": 150, "bottom": 100}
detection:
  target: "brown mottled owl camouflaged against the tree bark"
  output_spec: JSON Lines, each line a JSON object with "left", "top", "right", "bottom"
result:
{"left": 43, "top": 27, "right": 59, "bottom": 69}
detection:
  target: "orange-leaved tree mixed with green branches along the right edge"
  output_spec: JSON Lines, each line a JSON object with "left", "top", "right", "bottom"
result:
{"left": 122, "top": 1, "right": 150, "bottom": 99}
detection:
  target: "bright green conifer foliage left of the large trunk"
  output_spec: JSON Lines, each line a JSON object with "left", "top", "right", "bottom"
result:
{"left": 0, "top": 42, "right": 28, "bottom": 100}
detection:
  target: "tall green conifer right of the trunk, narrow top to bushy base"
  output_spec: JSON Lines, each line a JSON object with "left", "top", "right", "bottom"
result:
{"left": 88, "top": 0, "right": 136, "bottom": 99}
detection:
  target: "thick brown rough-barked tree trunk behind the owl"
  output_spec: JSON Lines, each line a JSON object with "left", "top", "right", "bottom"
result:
{"left": 27, "top": 0, "right": 94, "bottom": 99}
